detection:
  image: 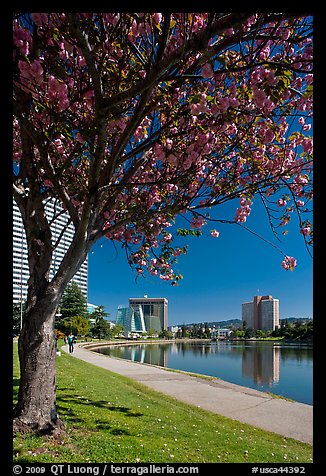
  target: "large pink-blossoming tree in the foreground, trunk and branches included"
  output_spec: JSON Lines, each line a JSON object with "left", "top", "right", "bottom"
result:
{"left": 13, "top": 13, "right": 313, "bottom": 432}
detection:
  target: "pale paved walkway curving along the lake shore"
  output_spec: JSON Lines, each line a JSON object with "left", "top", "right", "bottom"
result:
{"left": 63, "top": 344, "right": 313, "bottom": 444}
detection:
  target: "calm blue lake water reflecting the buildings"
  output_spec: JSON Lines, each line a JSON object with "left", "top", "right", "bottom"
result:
{"left": 97, "top": 341, "right": 313, "bottom": 405}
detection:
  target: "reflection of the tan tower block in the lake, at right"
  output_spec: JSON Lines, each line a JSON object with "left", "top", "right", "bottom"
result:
{"left": 242, "top": 346, "right": 281, "bottom": 387}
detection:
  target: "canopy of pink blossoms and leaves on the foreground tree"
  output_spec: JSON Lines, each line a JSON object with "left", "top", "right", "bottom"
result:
{"left": 14, "top": 13, "right": 312, "bottom": 281}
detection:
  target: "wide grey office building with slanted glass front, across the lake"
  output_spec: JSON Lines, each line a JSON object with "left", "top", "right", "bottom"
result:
{"left": 116, "top": 296, "right": 168, "bottom": 333}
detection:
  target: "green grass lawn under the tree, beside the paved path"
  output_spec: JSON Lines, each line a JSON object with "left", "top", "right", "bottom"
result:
{"left": 14, "top": 344, "right": 312, "bottom": 463}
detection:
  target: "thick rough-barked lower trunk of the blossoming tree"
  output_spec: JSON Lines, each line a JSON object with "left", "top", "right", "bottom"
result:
{"left": 13, "top": 289, "right": 63, "bottom": 433}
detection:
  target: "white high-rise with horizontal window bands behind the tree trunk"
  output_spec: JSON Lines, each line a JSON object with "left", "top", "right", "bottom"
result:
{"left": 13, "top": 200, "right": 88, "bottom": 304}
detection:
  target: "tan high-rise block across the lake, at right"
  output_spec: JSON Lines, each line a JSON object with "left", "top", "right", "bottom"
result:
{"left": 242, "top": 296, "right": 280, "bottom": 331}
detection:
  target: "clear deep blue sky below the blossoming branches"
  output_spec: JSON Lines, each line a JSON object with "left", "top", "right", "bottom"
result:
{"left": 88, "top": 200, "right": 313, "bottom": 325}
